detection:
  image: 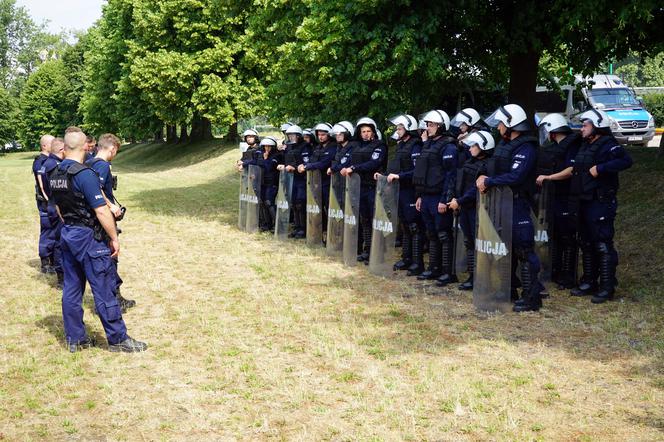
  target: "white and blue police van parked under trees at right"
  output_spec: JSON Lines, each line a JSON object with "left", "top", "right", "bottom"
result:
{"left": 535, "top": 74, "right": 655, "bottom": 146}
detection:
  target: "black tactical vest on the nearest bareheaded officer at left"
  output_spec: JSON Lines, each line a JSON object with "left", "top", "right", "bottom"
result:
{"left": 49, "top": 163, "right": 101, "bottom": 230}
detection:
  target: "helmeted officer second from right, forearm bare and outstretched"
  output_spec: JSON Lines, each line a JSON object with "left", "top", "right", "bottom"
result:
{"left": 537, "top": 114, "right": 581, "bottom": 289}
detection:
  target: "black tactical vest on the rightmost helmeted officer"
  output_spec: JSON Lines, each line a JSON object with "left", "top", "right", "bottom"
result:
{"left": 570, "top": 135, "right": 618, "bottom": 201}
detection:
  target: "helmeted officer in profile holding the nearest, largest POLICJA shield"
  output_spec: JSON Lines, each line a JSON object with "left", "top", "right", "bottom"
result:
{"left": 477, "top": 104, "right": 544, "bottom": 312}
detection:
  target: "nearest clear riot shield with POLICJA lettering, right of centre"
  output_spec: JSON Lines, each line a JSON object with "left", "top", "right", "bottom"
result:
{"left": 473, "top": 187, "right": 513, "bottom": 311}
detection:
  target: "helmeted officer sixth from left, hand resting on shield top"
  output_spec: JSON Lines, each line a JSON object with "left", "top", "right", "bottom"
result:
{"left": 340, "top": 117, "right": 387, "bottom": 264}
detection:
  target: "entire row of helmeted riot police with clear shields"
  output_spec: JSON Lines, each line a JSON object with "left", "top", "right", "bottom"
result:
{"left": 237, "top": 104, "right": 631, "bottom": 312}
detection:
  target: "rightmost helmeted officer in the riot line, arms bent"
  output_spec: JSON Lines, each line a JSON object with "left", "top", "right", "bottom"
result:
{"left": 570, "top": 109, "right": 632, "bottom": 304}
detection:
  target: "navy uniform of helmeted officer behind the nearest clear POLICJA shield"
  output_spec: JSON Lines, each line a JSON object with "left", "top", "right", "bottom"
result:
{"left": 484, "top": 135, "right": 544, "bottom": 308}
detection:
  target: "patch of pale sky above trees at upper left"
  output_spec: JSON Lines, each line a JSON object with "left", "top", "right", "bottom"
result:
{"left": 16, "top": 0, "right": 106, "bottom": 33}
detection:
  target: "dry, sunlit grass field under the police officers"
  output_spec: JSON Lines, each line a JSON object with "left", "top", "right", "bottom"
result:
{"left": 0, "top": 142, "right": 664, "bottom": 441}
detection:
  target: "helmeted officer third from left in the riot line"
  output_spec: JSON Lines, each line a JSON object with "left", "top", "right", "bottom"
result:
{"left": 278, "top": 124, "right": 311, "bottom": 239}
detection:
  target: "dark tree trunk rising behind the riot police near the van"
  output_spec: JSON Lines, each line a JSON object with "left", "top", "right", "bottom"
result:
{"left": 508, "top": 49, "right": 540, "bottom": 123}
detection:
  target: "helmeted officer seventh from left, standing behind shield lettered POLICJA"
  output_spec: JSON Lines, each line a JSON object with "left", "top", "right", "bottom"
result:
{"left": 375, "top": 114, "right": 424, "bottom": 275}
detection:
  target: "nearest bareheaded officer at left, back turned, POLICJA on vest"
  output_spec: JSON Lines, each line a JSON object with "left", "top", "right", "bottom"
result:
{"left": 50, "top": 132, "right": 147, "bottom": 352}
